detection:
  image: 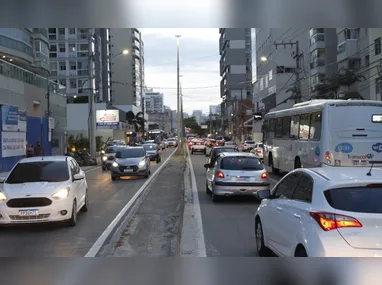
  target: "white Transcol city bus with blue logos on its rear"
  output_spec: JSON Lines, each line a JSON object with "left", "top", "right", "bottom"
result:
{"left": 262, "top": 100, "right": 382, "bottom": 173}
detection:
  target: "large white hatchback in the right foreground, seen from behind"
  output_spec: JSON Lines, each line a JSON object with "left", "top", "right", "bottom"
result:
{"left": 254, "top": 162, "right": 382, "bottom": 257}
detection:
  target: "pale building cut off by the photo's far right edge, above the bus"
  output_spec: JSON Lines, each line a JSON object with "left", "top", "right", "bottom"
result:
{"left": 365, "top": 28, "right": 382, "bottom": 101}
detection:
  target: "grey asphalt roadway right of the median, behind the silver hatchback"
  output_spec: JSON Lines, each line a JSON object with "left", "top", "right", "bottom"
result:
{"left": 191, "top": 154, "right": 281, "bottom": 257}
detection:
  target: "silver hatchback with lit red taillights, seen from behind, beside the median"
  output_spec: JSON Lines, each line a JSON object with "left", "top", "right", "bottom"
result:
{"left": 204, "top": 152, "right": 270, "bottom": 202}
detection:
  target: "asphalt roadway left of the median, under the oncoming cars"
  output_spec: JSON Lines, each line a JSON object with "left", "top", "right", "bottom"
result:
{"left": 0, "top": 149, "right": 173, "bottom": 257}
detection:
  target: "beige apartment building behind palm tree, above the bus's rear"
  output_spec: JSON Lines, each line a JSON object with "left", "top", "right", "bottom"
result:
{"left": 337, "top": 28, "right": 370, "bottom": 99}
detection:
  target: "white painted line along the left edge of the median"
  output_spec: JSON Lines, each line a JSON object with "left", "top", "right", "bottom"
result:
{"left": 85, "top": 149, "right": 177, "bottom": 257}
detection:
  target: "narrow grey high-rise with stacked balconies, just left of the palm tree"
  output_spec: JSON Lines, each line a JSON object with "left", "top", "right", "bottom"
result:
{"left": 309, "top": 28, "right": 338, "bottom": 97}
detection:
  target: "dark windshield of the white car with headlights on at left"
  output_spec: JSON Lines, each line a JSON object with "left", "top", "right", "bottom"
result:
{"left": 6, "top": 160, "right": 69, "bottom": 184}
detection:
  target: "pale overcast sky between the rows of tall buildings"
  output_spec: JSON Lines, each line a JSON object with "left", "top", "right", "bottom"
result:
{"left": 140, "top": 29, "right": 221, "bottom": 114}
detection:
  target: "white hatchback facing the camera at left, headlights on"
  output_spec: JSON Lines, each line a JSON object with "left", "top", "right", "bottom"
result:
{"left": 0, "top": 156, "right": 89, "bottom": 226}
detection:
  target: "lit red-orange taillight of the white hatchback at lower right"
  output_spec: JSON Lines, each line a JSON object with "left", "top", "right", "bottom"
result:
{"left": 310, "top": 212, "right": 362, "bottom": 231}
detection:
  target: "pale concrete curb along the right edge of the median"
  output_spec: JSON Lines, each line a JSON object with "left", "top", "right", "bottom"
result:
{"left": 187, "top": 148, "right": 207, "bottom": 257}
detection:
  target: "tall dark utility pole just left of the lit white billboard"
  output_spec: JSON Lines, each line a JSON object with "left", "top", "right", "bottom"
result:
{"left": 88, "top": 29, "right": 96, "bottom": 159}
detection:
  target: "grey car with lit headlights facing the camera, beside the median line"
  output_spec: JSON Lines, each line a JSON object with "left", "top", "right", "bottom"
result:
{"left": 110, "top": 147, "right": 151, "bottom": 180}
